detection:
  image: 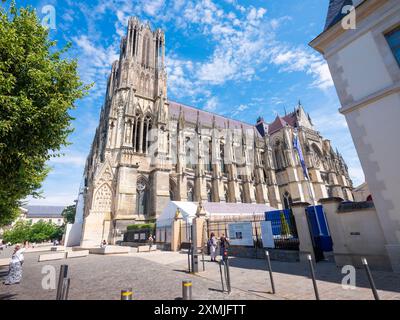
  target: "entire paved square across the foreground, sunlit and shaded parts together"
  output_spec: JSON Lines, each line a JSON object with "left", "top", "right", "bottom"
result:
{"left": 0, "top": 252, "right": 400, "bottom": 300}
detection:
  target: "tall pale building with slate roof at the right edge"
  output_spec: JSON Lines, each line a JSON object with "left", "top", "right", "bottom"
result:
{"left": 310, "top": 0, "right": 400, "bottom": 272}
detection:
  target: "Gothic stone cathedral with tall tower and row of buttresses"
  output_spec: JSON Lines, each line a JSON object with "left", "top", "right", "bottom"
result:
{"left": 81, "top": 18, "right": 353, "bottom": 247}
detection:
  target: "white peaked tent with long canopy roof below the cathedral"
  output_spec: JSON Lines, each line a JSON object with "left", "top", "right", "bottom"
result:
{"left": 156, "top": 201, "right": 277, "bottom": 228}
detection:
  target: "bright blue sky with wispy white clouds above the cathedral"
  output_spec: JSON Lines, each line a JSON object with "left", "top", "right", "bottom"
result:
{"left": 4, "top": 0, "right": 364, "bottom": 205}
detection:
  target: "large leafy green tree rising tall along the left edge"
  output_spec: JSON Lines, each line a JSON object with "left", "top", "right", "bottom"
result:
{"left": 0, "top": 1, "right": 89, "bottom": 225}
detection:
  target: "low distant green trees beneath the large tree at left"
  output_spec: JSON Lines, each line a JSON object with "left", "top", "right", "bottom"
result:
{"left": 3, "top": 220, "right": 64, "bottom": 244}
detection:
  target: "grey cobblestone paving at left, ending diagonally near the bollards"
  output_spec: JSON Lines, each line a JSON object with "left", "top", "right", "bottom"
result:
{"left": 0, "top": 252, "right": 263, "bottom": 300}
